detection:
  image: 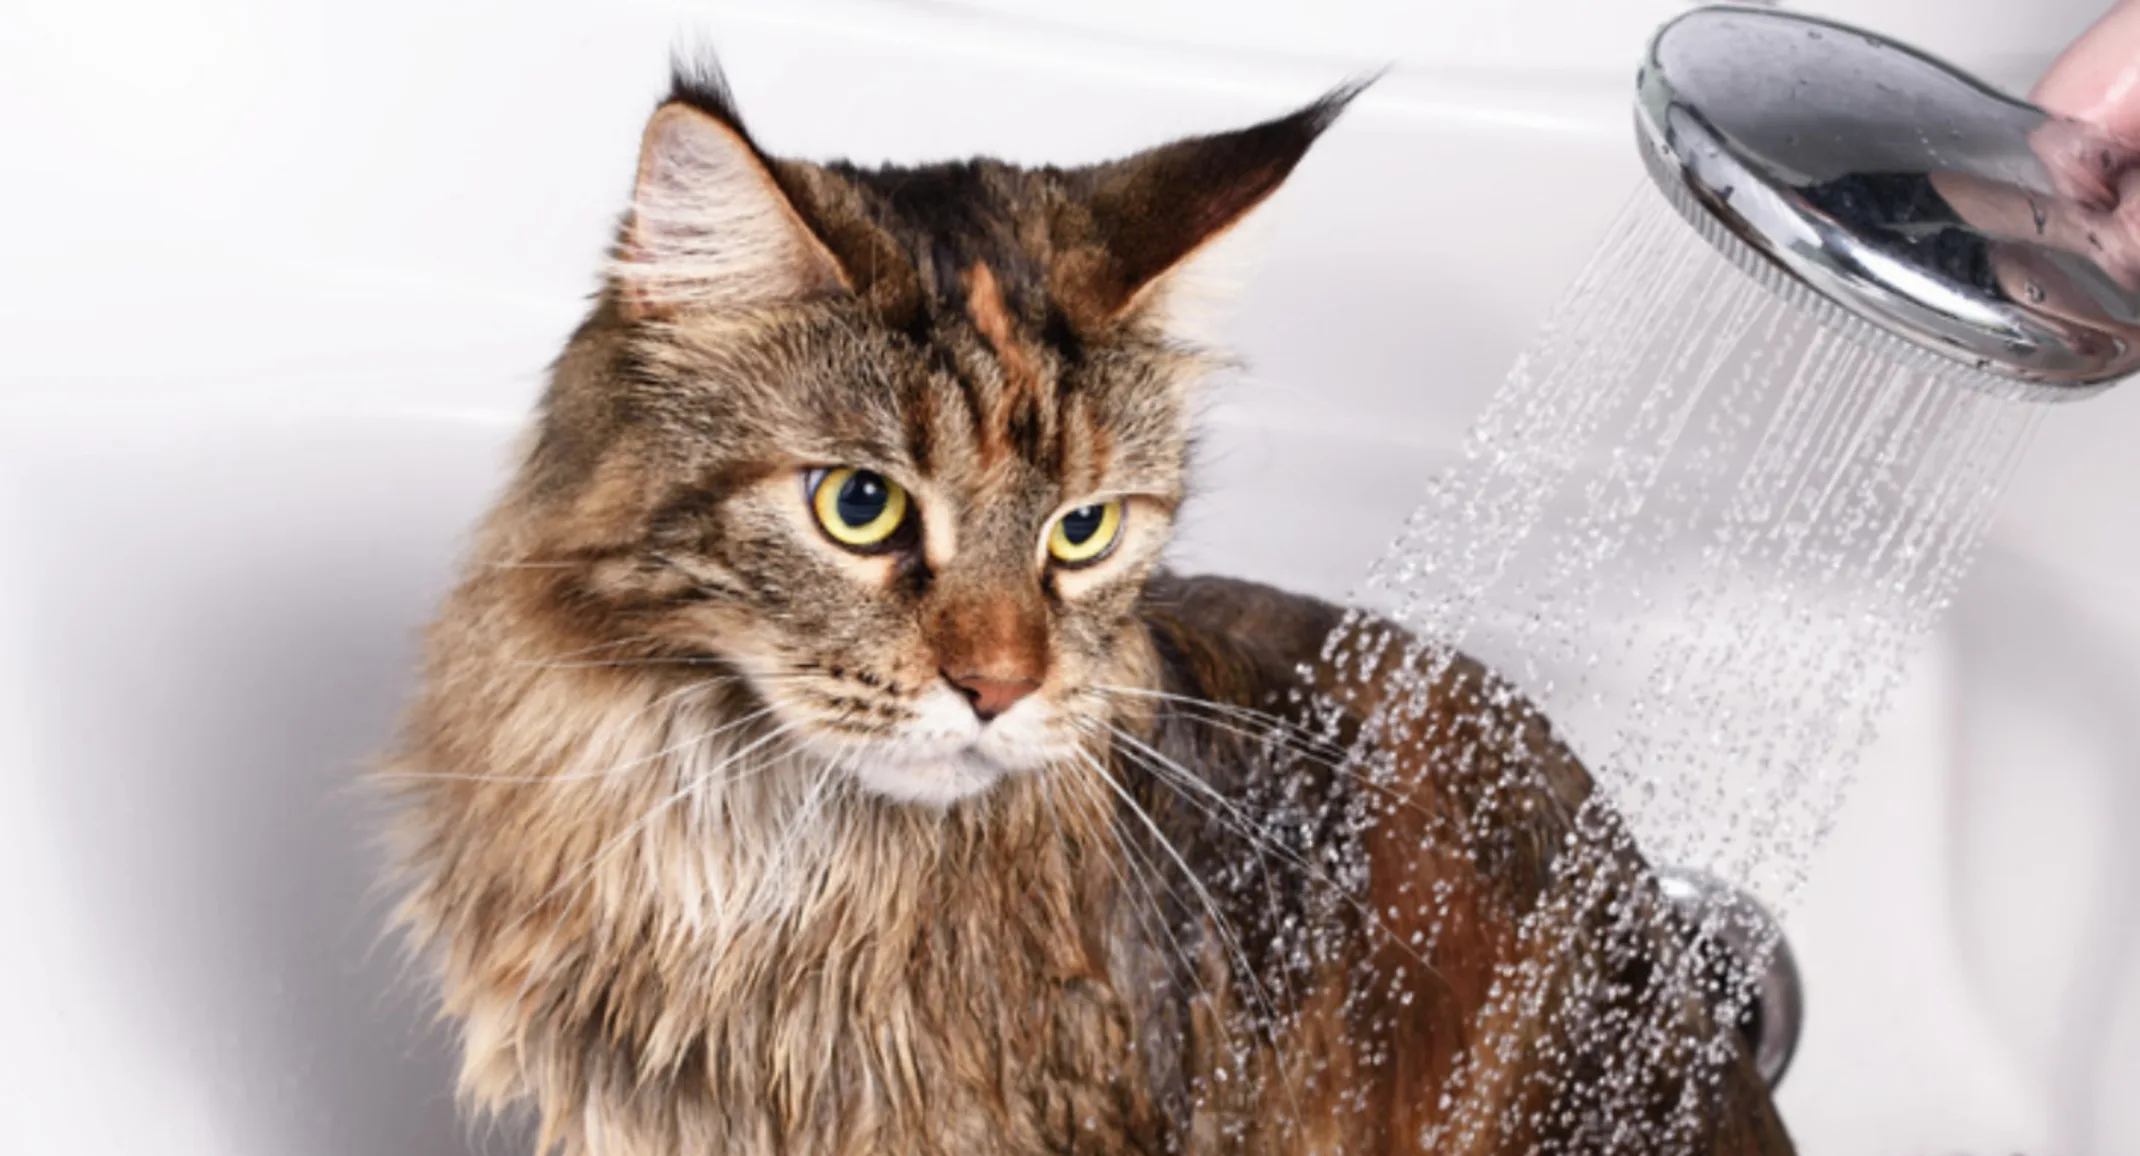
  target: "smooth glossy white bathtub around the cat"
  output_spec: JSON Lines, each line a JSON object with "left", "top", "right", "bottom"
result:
{"left": 0, "top": 0, "right": 2140, "bottom": 1156}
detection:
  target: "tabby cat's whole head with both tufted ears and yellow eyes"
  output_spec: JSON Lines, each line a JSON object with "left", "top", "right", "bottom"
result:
{"left": 514, "top": 63, "right": 1352, "bottom": 805}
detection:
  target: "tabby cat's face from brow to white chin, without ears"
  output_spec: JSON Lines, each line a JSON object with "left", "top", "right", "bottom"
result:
{"left": 577, "top": 302, "right": 1186, "bottom": 803}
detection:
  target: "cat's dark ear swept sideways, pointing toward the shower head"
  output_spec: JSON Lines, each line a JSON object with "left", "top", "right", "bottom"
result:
{"left": 1061, "top": 77, "right": 1372, "bottom": 323}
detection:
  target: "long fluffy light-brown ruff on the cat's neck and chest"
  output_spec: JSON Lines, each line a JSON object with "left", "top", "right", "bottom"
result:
{"left": 407, "top": 655, "right": 1119, "bottom": 1152}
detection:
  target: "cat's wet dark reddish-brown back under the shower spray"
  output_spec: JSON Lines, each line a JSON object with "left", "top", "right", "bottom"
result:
{"left": 1126, "top": 576, "right": 1791, "bottom": 1156}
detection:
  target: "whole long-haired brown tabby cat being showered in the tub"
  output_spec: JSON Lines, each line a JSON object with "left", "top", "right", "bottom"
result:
{"left": 387, "top": 71, "right": 1789, "bottom": 1156}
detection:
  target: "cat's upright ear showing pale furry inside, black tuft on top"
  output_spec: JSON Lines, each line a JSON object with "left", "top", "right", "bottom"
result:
{"left": 612, "top": 73, "right": 850, "bottom": 317}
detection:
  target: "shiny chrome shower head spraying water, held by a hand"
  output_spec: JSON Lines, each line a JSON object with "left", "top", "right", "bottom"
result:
{"left": 1635, "top": 6, "right": 2140, "bottom": 400}
